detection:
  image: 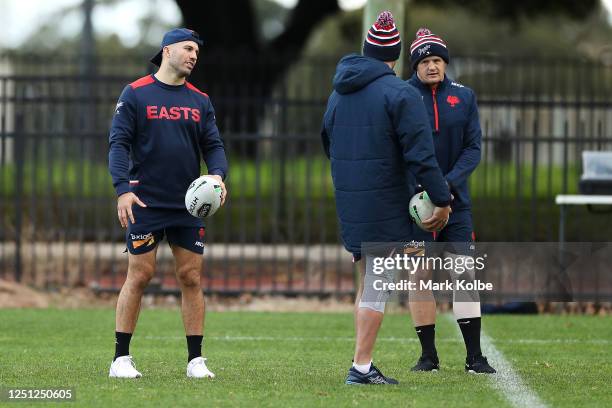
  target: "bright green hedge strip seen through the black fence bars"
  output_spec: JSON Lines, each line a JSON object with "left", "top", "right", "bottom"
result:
{"left": 0, "top": 156, "right": 579, "bottom": 201}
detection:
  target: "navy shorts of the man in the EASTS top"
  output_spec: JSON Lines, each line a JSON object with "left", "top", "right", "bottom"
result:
{"left": 125, "top": 206, "right": 206, "bottom": 255}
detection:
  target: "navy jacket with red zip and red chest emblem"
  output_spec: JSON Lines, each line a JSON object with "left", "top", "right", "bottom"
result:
{"left": 408, "top": 73, "right": 482, "bottom": 210}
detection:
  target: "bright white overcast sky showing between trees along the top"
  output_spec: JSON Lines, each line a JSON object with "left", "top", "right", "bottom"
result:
{"left": 0, "top": 0, "right": 612, "bottom": 47}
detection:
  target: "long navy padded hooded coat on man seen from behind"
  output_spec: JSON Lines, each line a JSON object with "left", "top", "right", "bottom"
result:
{"left": 321, "top": 55, "right": 450, "bottom": 254}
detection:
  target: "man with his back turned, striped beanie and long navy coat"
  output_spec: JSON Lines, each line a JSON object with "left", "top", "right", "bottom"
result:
{"left": 321, "top": 11, "right": 451, "bottom": 384}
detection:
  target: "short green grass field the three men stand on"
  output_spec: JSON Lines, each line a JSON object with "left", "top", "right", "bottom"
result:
{"left": 0, "top": 309, "right": 612, "bottom": 407}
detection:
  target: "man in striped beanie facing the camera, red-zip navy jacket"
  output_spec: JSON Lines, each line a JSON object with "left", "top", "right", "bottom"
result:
{"left": 408, "top": 28, "right": 495, "bottom": 373}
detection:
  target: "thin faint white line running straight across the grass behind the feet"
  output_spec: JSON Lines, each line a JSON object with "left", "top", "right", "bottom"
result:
{"left": 141, "top": 336, "right": 612, "bottom": 345}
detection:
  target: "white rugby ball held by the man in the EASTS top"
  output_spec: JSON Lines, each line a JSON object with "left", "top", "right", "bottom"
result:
{"left": 185, "top": 176, "right": 223, "bottom": 218}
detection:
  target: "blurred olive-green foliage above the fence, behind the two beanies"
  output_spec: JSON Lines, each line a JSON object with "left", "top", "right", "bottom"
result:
{"left": 305, "top": 2, "right": 612, "bottom": 59}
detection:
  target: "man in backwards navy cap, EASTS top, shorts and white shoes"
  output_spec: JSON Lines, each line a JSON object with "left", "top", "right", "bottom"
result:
{"left": 109, "top": 28, "right": 227, "bottom": 378}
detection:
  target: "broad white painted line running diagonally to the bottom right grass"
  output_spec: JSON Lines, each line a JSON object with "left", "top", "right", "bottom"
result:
{"left": 445, "top": 314, "right": 546, "bottom": 408}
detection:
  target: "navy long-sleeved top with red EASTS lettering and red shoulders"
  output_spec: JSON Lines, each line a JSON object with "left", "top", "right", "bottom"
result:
{"left": 109, "top": 75, "right": 227, "bottom": 209}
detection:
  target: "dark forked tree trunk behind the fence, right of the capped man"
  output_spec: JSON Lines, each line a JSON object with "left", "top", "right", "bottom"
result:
{"left": 176, "top": 0, "right": 340, "bottom": 131}
